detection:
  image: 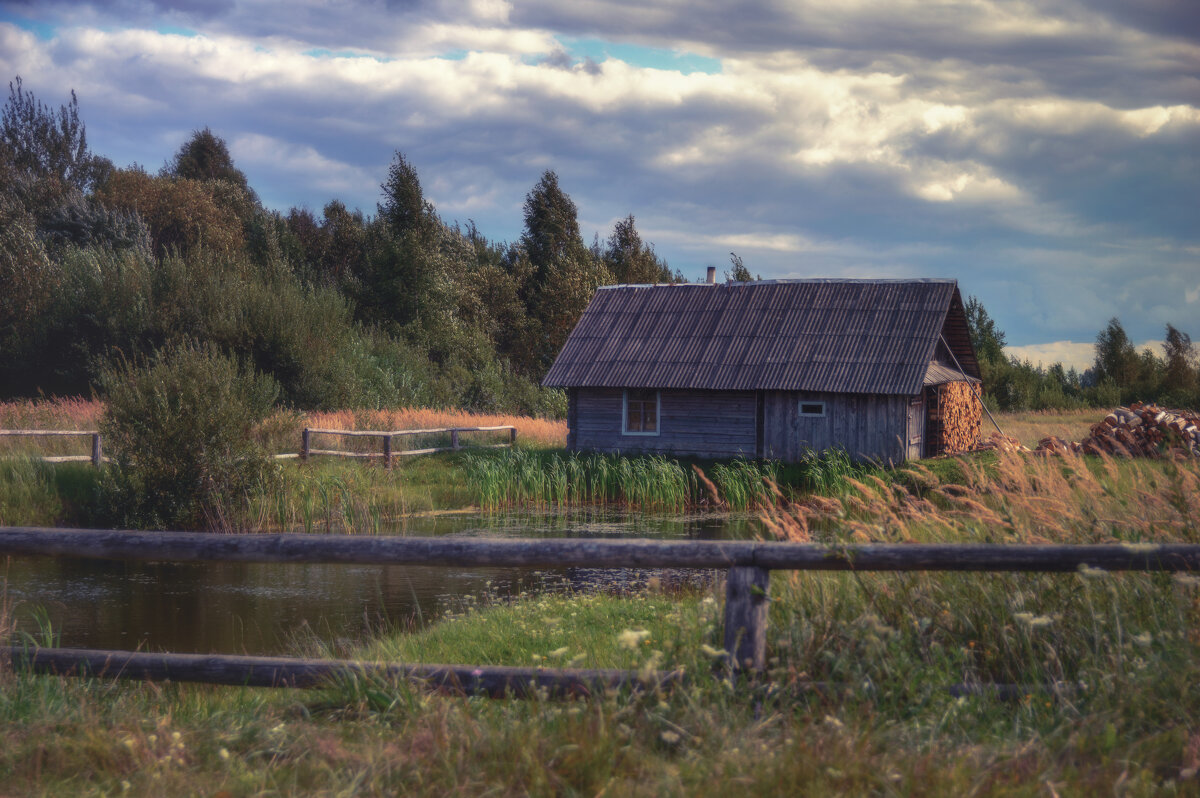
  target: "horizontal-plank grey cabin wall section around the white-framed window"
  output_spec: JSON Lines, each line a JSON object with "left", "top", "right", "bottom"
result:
{"left": 568, "top": 388, "right": 756, "bottom": 457}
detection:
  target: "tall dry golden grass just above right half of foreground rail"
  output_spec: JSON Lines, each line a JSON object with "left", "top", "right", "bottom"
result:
{"left": 767, "top": 452, "right": 1200, "bottom": 544}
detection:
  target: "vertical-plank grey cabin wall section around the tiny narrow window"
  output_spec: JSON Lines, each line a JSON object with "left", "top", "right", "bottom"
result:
{"left": 762, "top": 391, "right": 910, "bottom": 463}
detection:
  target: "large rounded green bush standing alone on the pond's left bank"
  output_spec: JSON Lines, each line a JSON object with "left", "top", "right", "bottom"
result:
{"left": 100, "top": 342, "right": 278, "bottom": 529}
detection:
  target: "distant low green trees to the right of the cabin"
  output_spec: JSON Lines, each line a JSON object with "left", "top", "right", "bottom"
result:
{"left": 965, "top": 296, "right": 1200, "bottom": 410}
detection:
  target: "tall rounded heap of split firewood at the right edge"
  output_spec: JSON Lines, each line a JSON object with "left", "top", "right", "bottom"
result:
{"left": 1080, "top": 402, "right": 1200, "bottom": 457}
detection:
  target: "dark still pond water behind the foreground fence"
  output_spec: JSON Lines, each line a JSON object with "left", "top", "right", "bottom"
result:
{"left": 0, "top": 514, "right": 755, "bottom": 654}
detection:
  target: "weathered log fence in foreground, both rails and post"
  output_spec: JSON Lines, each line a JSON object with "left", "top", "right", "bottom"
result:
{"left": 0, "top": 527, "right": 1200, "bottom": 695}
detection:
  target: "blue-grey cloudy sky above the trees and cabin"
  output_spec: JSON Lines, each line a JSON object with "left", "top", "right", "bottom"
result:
{"left": 0, "top": 0, "right": 1200, "bottom": 365}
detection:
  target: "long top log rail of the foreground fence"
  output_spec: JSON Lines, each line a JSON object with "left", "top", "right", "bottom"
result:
{"left": 0, "top": 527, "right": 1200, "bottom": 572}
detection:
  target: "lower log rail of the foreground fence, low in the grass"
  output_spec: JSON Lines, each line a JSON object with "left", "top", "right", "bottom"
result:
{"left": 8, "top": 646, "right": 683, "bottom": 697}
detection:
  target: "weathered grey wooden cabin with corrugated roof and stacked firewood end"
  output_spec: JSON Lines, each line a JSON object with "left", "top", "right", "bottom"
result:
{"left": 542, "top": 277, "right": 983, "bottom": 463}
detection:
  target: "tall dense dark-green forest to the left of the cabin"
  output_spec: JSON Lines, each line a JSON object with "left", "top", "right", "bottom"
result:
{"left": 0, "top": 78, "right": 683, "bottom": 415}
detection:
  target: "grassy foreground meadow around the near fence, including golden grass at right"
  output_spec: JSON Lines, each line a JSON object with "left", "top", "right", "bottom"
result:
{"left": 0, "top": 408, "right": 1200, "bottom": 796}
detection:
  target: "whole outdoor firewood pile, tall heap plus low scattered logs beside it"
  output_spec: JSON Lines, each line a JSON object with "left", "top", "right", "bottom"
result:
{"left": 978, "top": 402, "right": 1200, "bottom": 457}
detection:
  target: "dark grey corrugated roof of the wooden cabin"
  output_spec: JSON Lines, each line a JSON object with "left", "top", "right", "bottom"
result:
{"left": 542, "top": 280, "right": 977, "bottom": 396}
